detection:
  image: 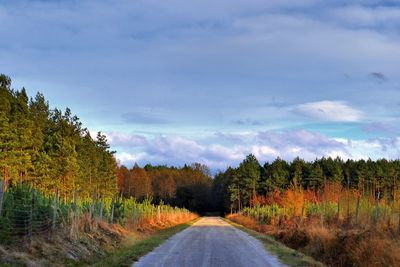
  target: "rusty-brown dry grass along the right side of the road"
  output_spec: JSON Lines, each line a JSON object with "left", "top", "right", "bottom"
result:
{"left": 228, "top": 214, "right": 400, "bottom": 267}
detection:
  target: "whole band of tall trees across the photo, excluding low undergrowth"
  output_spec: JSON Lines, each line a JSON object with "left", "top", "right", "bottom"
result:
{"left": 0, "top": 75, "right": 400, "bottom": 216}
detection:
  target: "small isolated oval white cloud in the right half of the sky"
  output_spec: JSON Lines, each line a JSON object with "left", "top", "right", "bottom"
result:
{"left": 293, "top": 101, "right": 362, "bottom": 122}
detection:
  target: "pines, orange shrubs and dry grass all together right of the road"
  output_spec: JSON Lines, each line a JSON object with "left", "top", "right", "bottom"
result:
{"left": 214, "top": 155, "right": 400, "bottom": 266}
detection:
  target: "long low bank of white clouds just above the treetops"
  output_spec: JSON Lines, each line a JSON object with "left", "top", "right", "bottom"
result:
{"left": 108, "top": 130, "right": 400, "bottom": 170}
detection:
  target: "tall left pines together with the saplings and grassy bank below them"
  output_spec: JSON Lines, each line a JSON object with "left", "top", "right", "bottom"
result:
{"left": 0, "top": 75, "right": 200, "bottom": 266}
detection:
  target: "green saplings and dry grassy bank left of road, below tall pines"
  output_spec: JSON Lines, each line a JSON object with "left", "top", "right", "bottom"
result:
{"left": 0, "top": 185, "right": 197, "bottom": 266}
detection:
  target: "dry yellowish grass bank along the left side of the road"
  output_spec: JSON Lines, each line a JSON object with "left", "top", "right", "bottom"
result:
{"left": 0, "top": 213, "right": 197, "bottom": 266}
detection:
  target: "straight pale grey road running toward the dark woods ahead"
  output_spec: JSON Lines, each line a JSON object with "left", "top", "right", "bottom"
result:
{"left": 133, "top": 217, "right": 284, "bottom": 267}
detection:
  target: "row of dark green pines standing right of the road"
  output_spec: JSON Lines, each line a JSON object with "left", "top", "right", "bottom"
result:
{"left": 212, "top": 154, "right": 400, "bottom": 212}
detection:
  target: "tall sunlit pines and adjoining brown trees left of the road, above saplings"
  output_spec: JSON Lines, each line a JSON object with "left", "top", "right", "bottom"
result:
{"left": 0, "top": 75, "right": 212, "bottom": 215}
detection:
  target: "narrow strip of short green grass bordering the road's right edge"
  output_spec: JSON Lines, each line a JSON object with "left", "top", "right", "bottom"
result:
{"left": 225, "top": 219, "right": 325, "bottom": 267}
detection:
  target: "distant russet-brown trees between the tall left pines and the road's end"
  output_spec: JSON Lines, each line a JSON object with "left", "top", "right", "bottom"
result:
{"left": 118, "top": 163, "right": 213, "bottom": 213}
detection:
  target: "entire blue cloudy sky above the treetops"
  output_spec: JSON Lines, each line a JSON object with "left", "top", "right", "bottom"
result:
{"left": 0, "top": 0, "right": 400, "bottom": 170}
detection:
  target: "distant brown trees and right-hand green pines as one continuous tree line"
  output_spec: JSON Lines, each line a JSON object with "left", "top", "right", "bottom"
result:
{"left": 118, "top": 154, "right": 400, "bottom": 217}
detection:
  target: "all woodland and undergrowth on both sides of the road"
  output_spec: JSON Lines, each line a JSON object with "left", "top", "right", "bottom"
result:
{"left": 0, "top": 75, "right": 400, "bottom": 266}
